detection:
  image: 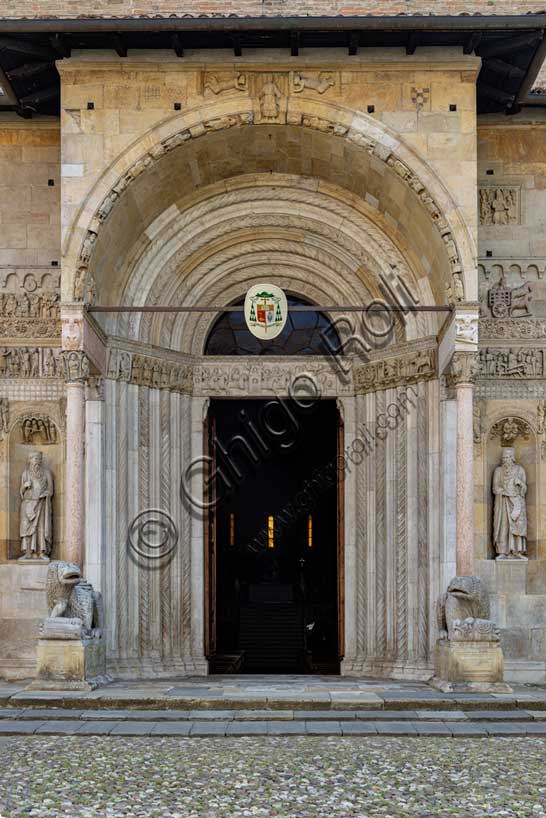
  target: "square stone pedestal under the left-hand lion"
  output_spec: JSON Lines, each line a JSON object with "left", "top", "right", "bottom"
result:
{"left": 27, "top": 637, "right": 109, "bottom": 690}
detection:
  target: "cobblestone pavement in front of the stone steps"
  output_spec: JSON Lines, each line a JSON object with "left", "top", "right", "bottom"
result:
{"left": 0, "top": 736, "right": 546, "bottom": 818}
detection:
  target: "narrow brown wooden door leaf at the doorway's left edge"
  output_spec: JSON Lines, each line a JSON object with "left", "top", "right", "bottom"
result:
{"left": 203, "top": 408, "right": 217, "bottom": 664}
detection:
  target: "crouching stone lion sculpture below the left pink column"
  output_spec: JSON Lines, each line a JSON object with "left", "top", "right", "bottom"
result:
{"left": 40, "top": 560, "right": 104, "bottom": 639}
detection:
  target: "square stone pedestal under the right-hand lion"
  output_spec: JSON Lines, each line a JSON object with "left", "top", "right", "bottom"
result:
{"left": 430, "top": 639, "right": 512, "bottom": 693}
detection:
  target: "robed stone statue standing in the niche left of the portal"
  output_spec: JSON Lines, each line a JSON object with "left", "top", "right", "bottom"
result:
{"left": 19, "top": 451, "right": 53, "bottom": 560}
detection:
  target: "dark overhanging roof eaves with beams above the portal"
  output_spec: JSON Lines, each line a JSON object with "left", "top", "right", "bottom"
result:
{"left": 0, "top": 14, "right": 546, "bottom": 116}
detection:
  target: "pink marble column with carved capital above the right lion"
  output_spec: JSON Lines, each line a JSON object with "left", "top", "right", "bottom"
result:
{"left": 450, "top": 352, "right": 477, "bottom": 576}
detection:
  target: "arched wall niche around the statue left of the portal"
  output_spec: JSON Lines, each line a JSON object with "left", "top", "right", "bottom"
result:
{"left": 6, "top": 402, "right": 65, "bottom": 560}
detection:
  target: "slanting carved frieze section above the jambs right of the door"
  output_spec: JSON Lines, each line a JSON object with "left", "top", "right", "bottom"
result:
{"left": 354, "top": 349, "right": 438, "bottom": 394}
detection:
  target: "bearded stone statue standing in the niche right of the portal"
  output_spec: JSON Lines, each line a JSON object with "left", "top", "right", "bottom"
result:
{"left": 493, "top": 446, "right": 527, "bottom": 559}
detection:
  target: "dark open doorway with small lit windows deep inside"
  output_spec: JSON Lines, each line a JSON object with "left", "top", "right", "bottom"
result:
{"left": 206, "top": 399, "right": 343, "bottom": 673}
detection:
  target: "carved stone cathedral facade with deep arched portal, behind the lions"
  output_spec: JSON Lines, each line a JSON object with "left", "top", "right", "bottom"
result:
{"left": 0, "top": 0, "right": 546, "bottom": 684}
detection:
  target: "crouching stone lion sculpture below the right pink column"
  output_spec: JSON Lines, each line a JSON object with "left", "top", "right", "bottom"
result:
{"left": 438, "top": 577, "right": 499, "bottom": 642}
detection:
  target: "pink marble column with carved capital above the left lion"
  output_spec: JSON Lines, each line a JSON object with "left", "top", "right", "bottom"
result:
{"left": 64, "top": 352, "right": 89, "bottom": 567}
